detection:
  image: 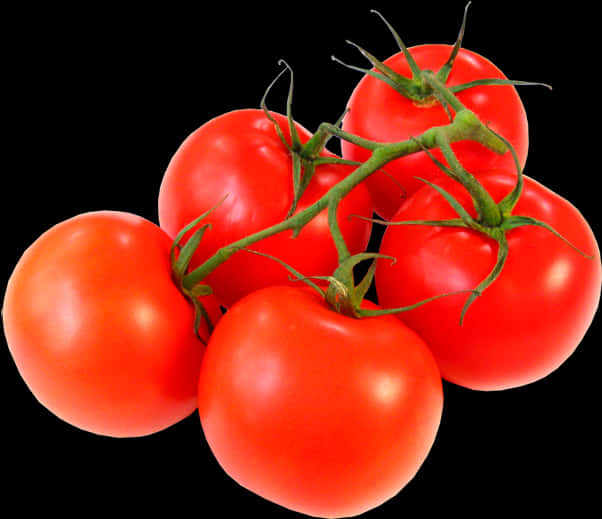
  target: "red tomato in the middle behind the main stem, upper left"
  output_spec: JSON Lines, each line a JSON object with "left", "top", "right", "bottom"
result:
{"left": 159, "top": 109, "right": 372, "bottom": 307}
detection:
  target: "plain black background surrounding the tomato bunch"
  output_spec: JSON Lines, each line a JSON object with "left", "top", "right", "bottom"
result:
{"left": 0, "top": 1, "right": 602, "bottom": 519}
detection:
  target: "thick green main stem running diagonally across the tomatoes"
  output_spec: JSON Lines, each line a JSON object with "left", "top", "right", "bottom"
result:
{"left": 182, "top": 103, "right": 508, "bottom": 290}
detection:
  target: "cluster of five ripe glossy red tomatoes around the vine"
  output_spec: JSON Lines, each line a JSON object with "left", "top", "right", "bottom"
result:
{"left": 2, "top": 7, "right": 602, "bottom": 517}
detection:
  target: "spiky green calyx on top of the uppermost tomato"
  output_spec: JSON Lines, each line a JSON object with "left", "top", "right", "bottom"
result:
{"left": 332, "top": 2, "right": 551, "bottom": 108}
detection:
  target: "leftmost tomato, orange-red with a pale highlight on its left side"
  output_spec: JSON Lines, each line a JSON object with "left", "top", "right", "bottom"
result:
{"left": 2, "top": 211, "right": 221, "bottom": 437}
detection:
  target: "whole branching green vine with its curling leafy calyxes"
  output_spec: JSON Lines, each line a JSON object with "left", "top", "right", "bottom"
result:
{"left": 174, "top": 9, "right": 581, "bottom": 338}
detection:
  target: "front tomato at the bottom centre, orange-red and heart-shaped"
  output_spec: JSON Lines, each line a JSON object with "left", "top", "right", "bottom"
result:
{"left": 199, "top": 286, "right": 443, "bottom": 517}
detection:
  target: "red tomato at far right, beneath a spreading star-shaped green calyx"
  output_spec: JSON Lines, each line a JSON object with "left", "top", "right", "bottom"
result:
{"left": 375, "top": 171, "right": 601, "bottom": 390}
